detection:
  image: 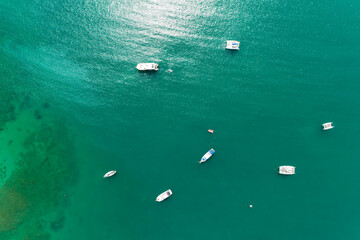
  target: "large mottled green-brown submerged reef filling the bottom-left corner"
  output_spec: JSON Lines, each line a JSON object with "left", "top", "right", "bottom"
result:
{"left": 0, "top": 121, "right": 76, "bottom": 239}
